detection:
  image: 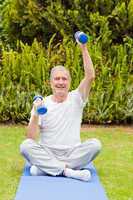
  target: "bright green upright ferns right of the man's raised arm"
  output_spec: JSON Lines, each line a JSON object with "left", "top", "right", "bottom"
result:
{"left": 85, "top": 38, "right": 133, "bottom": 123}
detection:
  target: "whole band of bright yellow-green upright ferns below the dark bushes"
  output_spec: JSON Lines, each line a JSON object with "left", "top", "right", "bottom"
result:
{"left": 0, "top": 35, "right": 133, "bottom": 124}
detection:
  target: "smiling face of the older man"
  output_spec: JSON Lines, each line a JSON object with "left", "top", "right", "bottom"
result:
{"left": 51, "top": 71, "right": 70, "bottom": 96}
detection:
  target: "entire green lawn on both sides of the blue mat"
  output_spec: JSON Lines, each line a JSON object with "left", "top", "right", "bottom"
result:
{"left": 0, "top": 126, "right": 133, "bottom": 200}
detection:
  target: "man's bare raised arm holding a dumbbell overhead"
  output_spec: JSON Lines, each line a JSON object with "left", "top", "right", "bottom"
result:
{"left": 78, "top": 44, "right": 95, "bottom": 100}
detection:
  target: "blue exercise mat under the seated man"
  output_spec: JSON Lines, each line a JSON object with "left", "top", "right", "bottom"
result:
{"left": 15, "top": 164, "right": 108, "bottom": 200}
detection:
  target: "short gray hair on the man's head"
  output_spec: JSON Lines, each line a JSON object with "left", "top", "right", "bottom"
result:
{"left": 50, "top": 65, "right": 71, "bottom": 80}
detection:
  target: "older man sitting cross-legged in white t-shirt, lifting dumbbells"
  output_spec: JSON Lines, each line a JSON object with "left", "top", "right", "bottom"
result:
{"left": 20, "top": 44, "right": 101, "bottom": 181}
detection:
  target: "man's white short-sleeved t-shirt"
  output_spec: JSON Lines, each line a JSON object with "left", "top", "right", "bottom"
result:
{"left": 35, "top": 89, "right": 85, "bottom": 147}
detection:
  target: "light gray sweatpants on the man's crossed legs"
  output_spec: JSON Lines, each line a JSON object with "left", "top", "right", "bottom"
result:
{"left": 20, "top": 139, "right": 101, "bottom": 176}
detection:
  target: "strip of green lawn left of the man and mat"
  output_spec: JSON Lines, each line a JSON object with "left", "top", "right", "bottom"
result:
{"left": 0, "top": 126, "right": 24, "bottom": 200}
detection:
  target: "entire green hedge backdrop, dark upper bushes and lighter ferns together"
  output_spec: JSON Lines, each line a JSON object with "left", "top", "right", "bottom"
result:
{"left": 0, "top": 0, "right": 133, "bottom": 123}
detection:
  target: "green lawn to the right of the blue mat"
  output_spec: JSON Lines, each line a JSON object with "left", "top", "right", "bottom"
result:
{"left": 82, "top": 127, "right": 133, "bottom": 200}
